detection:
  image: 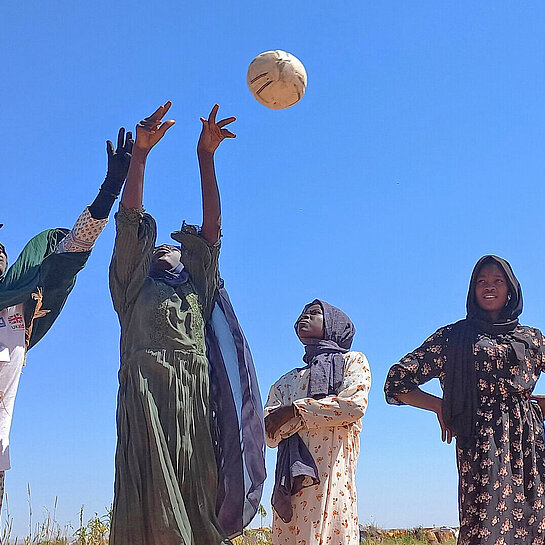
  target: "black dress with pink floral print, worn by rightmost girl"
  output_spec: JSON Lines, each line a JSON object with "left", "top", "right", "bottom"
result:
{"left": 384, "top": 326, "right": 545, "bottom": 545}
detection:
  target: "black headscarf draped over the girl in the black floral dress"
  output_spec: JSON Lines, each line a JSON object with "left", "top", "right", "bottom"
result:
{"left": 442, "top": 255, "right": 528, "bottom": 447}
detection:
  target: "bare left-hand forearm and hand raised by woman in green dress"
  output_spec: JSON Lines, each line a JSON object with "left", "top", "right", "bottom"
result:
{"left": 121, "top": 100, "right": 175, "bottom": 210}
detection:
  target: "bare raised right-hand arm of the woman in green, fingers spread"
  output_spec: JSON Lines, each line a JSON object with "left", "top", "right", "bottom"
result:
{"left": 197, "top": 104, "right": 236, "bottom": 244}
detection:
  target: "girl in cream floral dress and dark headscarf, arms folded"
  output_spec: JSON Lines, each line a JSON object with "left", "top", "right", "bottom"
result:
{"left": 265, "top": 300, "right": 371, "bottom": 545}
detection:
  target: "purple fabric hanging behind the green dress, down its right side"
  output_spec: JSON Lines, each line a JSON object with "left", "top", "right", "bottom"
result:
{"left": 206, "top": 281, "right": 266, "bottom": 537}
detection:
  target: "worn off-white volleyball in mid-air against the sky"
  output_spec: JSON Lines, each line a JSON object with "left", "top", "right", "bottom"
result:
{"left": 246, "top": 49, "right": 307, "bottom": 110}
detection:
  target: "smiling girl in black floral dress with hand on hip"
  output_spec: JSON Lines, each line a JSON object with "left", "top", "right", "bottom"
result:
{"left": 384, "top": 255, "right": 545, "bottom": 545}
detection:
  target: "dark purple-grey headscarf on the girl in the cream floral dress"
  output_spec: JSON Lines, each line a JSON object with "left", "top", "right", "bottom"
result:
{"left": 295, "top": 299, "right": 356, "bottom": 399}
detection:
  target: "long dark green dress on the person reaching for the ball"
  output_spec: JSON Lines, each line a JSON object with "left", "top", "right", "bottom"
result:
{"left": 110, "top": 206, "right": 223, "bottom": 545}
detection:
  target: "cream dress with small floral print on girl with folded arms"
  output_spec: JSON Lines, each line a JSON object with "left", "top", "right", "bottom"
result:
{"left": 265, "top": 352, "right": 371, "bottom": 545}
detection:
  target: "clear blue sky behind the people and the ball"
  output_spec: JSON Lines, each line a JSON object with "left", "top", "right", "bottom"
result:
{"left": 0, "top": 0, "right": 545, "bottom": 536}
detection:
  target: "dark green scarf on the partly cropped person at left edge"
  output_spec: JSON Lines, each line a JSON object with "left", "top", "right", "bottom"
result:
{"left": 0, "top": 228, "right": 90, "bottom": 349}
